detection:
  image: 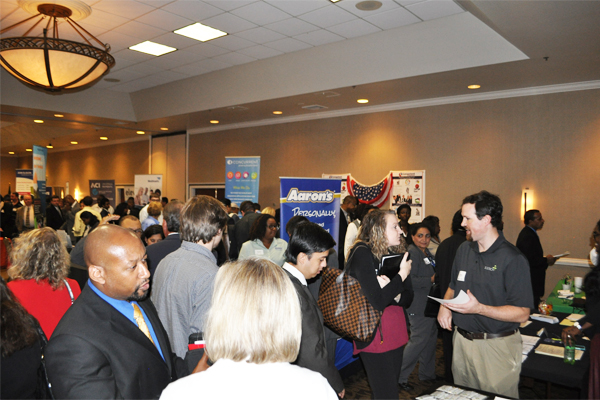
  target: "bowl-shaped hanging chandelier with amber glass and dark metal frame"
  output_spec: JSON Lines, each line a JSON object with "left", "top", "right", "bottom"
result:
{"left": 0, "top": 0, "right": 115, "bottom": 92}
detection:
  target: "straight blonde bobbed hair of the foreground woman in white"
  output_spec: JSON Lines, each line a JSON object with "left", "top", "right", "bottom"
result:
{"left": 204, "top": 257, "right": 302, "bottom": 364}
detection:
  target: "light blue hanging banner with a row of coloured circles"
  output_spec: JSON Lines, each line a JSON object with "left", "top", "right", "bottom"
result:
{"left": 225, "top": 157, "right": 260, "bottom": 205}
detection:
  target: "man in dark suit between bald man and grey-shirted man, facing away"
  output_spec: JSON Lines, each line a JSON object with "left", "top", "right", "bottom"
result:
{"left": 146, "top": 200, "right": 184, "bottom": 277}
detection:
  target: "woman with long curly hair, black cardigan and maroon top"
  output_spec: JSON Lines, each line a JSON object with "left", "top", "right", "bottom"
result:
{"left": 345, "top": 210, "right": 413, "bottom": 399}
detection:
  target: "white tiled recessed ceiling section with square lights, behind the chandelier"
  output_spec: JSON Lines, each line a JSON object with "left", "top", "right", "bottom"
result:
{"left": 0, "top": 0, "right": 465, "bottom": 93}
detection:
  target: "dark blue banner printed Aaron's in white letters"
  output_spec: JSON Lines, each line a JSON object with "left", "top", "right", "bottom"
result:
{"left": 279, "top": 178, "right": 341, "bottom": 251}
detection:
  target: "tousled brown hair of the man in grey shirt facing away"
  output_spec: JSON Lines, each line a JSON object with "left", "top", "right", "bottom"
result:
{"left": 180, "top": 196, "right": 229, "bottom": 244}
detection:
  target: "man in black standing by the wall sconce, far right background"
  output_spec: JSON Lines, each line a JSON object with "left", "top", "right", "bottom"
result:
{"left": 517, "top": 210, "right": 556, "bottom": 310}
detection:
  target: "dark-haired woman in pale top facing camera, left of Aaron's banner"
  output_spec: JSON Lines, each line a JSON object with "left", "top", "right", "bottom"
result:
{"left": 238, "top": 214, "right": 287, "bottom": 267}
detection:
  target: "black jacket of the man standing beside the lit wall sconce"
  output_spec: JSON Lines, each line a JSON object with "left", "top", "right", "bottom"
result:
{"left": 517, "top": 226, "right": 548, "bottom": 297}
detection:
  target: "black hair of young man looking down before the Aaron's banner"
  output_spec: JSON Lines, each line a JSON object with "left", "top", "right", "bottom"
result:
{"left": 286, "top": 222, "right": 335, "bottom": 264}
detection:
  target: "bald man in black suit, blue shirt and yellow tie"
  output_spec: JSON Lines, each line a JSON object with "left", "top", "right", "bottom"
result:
{"left": 46, "top": 225, "right": 189, "bottom": 399}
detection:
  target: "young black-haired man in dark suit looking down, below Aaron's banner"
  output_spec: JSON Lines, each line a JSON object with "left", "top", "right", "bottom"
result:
{"left": 283, "top": 222, "right": 345, "bottom": 397}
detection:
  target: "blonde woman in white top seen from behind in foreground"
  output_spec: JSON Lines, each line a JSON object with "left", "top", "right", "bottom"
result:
{"left": 161, "top": 257, "right": 337, "bottom": 400}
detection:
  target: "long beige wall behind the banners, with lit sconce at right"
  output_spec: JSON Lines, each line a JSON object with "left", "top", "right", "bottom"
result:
{"left": 189, "top": 90, "right": 600, "bottom": 258}
